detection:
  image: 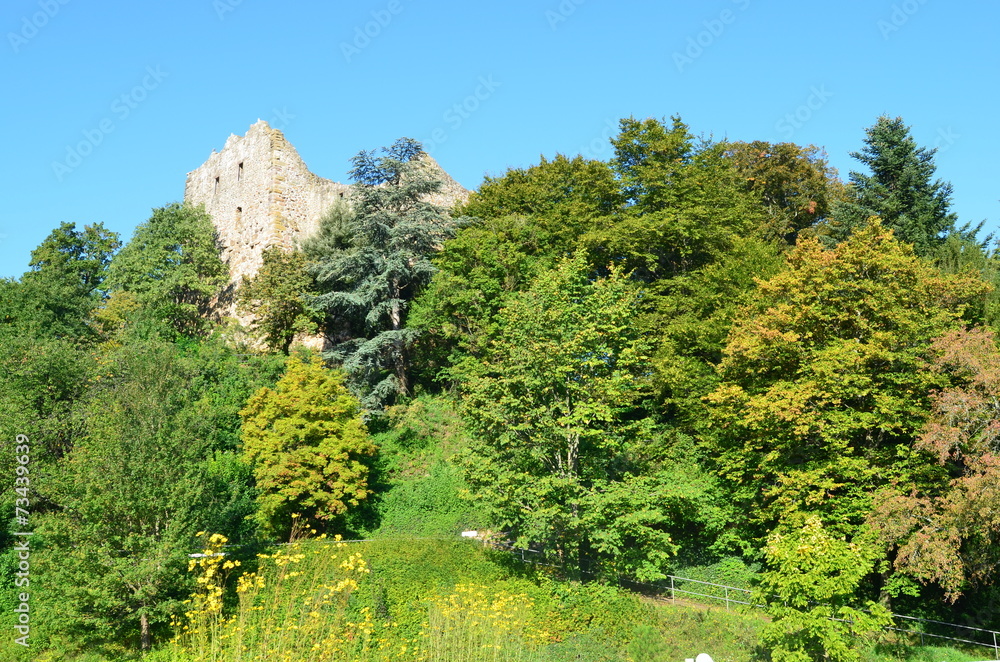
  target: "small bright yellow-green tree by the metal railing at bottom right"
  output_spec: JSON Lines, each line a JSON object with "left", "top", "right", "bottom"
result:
{"left": 754, "top": 516, "right": 892, "bottom": 662}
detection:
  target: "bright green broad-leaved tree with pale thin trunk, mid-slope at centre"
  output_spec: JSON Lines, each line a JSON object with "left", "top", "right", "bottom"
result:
{"left": 455, "top": 253, "right": 708, "bottom": 579}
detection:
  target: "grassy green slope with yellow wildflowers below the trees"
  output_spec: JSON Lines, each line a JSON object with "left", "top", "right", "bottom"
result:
{"left": 13, "top": 397, "right": 982, "bottom": 662}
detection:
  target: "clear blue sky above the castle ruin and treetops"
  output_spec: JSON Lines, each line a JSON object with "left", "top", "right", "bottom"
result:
{"left": 0, "top": 0, "right": 1000, "bottom": 277}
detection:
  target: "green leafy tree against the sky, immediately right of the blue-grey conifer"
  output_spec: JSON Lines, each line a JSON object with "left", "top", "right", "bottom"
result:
{"left": 408, "top": 155, "right": 620, "bottom": 392}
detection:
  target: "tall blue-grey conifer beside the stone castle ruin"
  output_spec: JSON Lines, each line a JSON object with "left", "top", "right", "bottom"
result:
{"left": 310, "top": 138, "right": 462, "bottom": 409}
